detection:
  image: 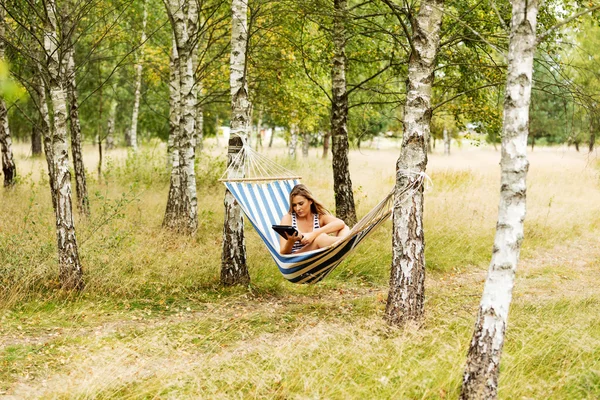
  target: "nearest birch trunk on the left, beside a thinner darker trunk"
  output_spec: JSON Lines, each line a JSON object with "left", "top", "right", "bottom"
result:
{"left": 44, "top": 0, "right": 84, "bottom": 290}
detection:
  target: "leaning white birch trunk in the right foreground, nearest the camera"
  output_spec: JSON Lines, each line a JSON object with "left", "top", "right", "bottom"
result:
{"left": 461, "top": 0, "right": 538, "bottom": 399}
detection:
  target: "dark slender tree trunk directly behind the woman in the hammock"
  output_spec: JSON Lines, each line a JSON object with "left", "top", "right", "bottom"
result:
{"left": 331, "top": 0, "right": 356, "bottom": 226}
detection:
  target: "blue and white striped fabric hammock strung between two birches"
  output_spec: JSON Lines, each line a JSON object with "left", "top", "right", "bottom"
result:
{"left": 221, "top": 140, "right": 425, "bottom": 283}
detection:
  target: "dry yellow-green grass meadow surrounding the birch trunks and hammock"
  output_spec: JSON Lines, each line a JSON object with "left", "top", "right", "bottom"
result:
{"left": 0, "top": 142, "right": 600, "bottom": 399}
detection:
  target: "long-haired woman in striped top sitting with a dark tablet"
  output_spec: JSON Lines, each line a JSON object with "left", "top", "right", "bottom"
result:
{"left": 279, "top": 184, "right": 350, "bottom": 254}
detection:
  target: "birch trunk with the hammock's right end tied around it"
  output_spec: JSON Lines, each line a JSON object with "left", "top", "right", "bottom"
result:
{"left": 385, "top": 0, "right": 444, "bottom": 325}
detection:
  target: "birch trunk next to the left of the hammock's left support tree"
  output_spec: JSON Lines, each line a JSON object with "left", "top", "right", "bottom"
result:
{"left": 163, "top": 0, "right": 198, "bottom": 234}
